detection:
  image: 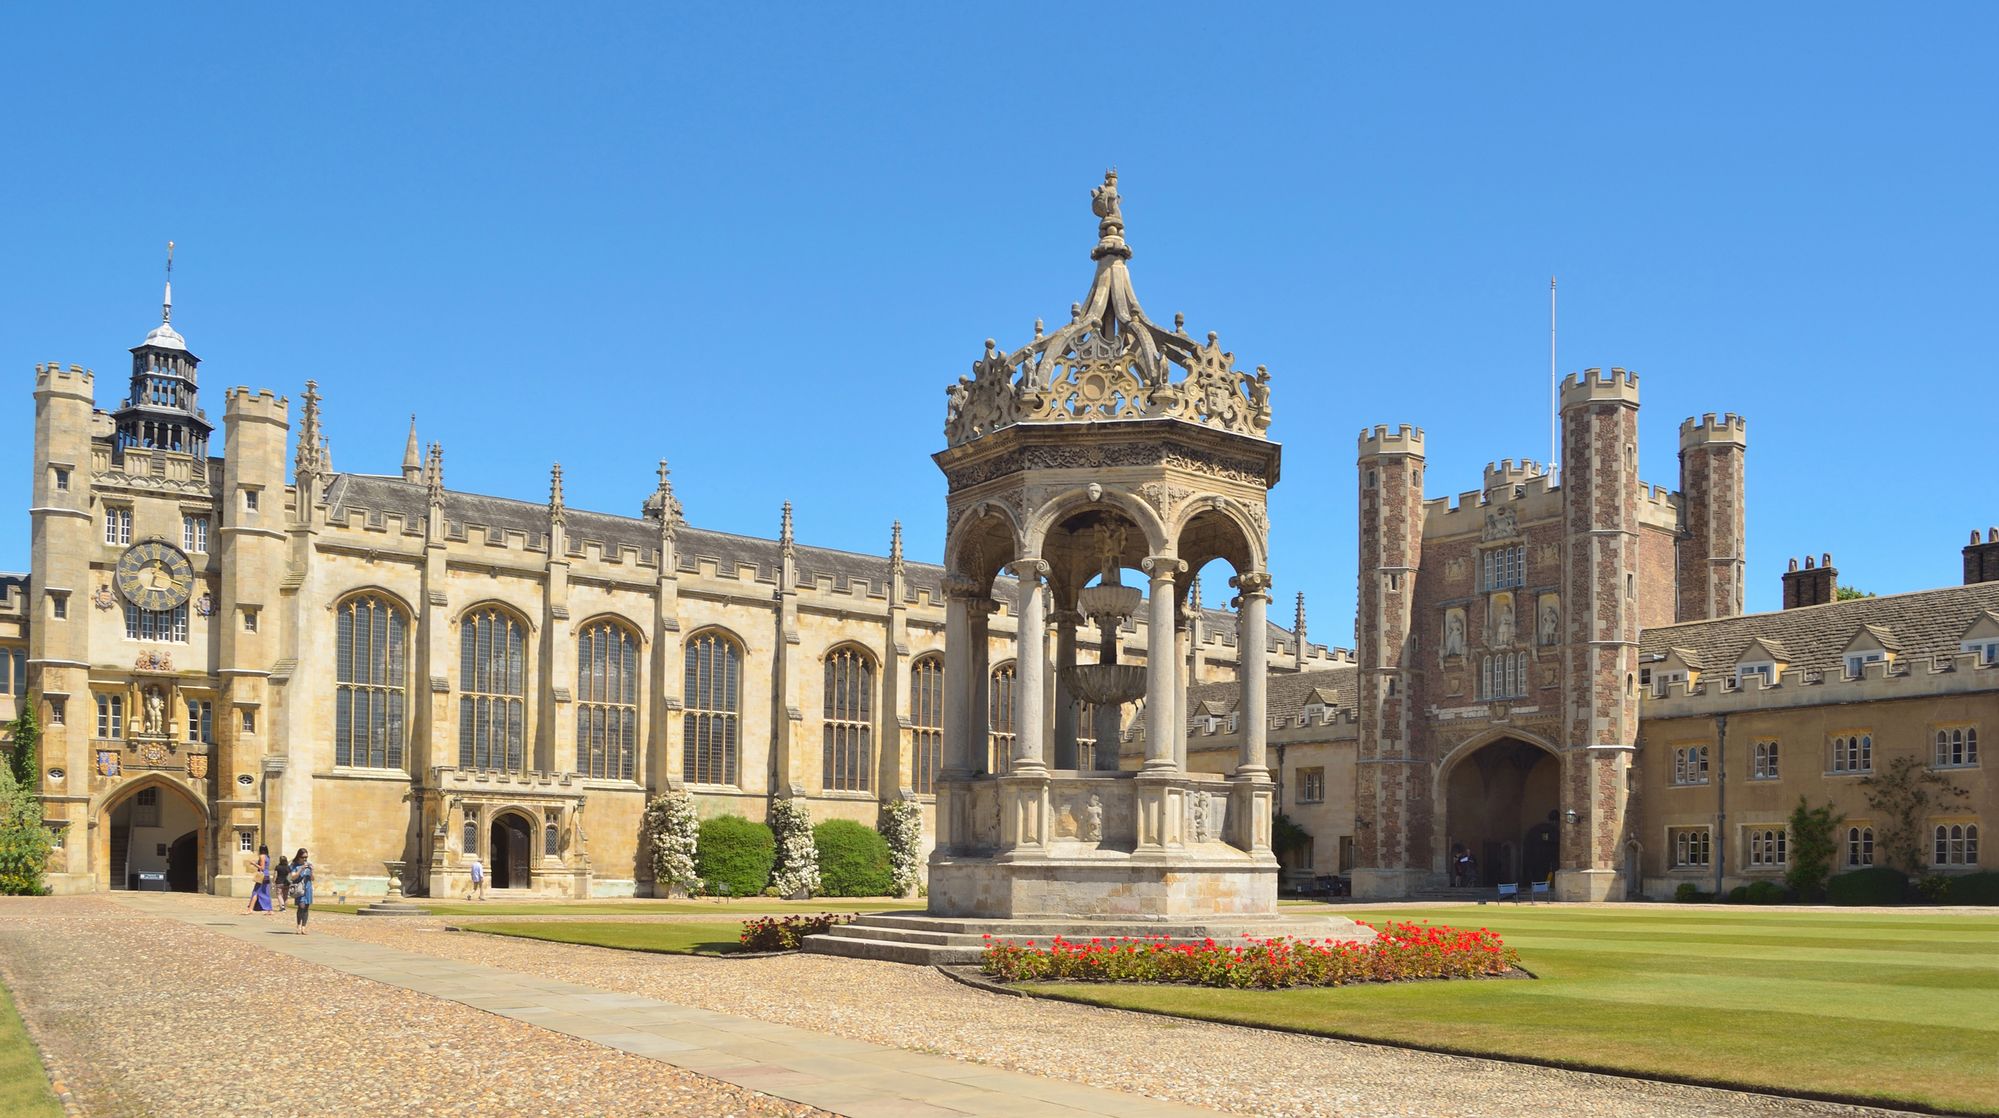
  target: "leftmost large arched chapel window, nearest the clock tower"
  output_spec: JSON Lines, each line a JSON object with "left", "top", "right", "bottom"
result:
{"left": 334, "top": 594, "right": 410, "bottom": 768}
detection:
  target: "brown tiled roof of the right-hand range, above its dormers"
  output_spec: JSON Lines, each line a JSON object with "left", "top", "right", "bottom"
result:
{"left": 1639, "top": 582, "right": 1999, "bottom": 672}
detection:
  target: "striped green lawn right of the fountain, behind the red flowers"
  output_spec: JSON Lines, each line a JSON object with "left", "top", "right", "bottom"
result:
{"left": 1023, "top": 904, "right": 1999, "bottom": 1114}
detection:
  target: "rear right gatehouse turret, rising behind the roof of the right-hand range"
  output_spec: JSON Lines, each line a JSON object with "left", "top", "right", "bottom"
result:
{"left": 1675, "top": 412, "right": 1749, "bottom": 622}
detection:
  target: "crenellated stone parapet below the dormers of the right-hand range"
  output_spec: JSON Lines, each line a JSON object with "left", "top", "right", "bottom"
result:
{"left": 1639, "top": 652, "right": 1999, "bottom": 718}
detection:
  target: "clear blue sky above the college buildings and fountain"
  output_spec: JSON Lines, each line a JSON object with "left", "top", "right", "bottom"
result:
{"left": 0, "top": 4, "right": 1999, "bottom": 644}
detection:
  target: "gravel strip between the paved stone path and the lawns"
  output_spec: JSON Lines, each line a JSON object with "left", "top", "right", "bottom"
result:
{"left": 314, "top": 904, "right": 1889, "bottom": 1118}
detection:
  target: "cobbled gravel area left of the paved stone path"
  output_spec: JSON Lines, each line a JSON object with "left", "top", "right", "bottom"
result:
{"left": 0, "top": 896, "right": 824, "bottom": 1118}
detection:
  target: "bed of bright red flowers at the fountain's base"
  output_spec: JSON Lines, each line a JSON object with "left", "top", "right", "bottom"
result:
{"left": 980, "top": 922, "right": 1519, "bottom": 990}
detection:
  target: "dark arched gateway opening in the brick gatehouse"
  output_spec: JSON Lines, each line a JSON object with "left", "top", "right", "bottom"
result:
{"left": 1443, "top": 738, "right": 1561, "bottom": 886}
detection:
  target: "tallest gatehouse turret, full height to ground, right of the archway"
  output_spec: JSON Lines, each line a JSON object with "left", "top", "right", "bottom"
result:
{"left": 1555, "top": 368, "right": 1639, "bottom": 900}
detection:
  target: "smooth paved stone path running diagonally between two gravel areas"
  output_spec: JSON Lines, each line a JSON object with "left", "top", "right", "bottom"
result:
{"left": 120, "top": 894, "right": 1213, "bottom": 1118}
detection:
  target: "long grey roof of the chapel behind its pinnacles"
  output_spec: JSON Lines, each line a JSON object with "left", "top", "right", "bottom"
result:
{"left": 326, "top": 474, "right": 1297, "bottom": 648}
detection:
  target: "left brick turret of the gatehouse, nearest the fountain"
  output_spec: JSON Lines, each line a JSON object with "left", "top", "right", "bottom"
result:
{"left": 1353, "top": 424, "right": 1429, "bottom": 896}
